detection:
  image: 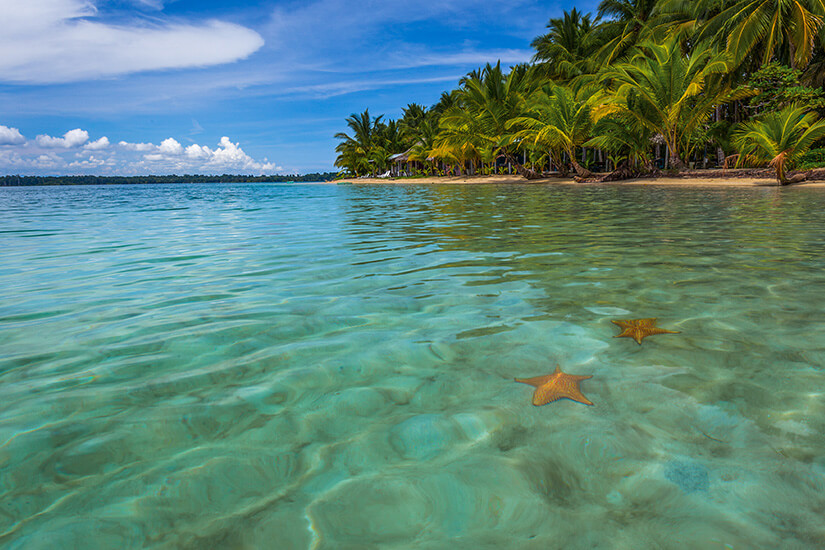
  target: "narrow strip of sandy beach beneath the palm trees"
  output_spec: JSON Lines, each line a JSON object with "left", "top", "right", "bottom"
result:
{"left": 332, "top": 174, "right": 825, "bottom": 189}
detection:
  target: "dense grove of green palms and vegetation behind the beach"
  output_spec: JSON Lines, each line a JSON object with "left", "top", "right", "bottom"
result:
{"left": 336, "top": 0, "right": 825, "bottom": 184}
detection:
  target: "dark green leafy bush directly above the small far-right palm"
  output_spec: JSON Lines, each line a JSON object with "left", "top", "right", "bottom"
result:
{"left": 748, "top": 62, "right": 825, "bottom": 115}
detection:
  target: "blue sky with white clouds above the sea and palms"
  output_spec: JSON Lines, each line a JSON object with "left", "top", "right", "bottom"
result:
{"left": 0, "top": 0, "right": 597, "bottom": 175}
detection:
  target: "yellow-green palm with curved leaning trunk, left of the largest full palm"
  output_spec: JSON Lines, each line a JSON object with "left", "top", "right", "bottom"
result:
{"left": 508, "top": 84, "right": 593, "bottom": 178}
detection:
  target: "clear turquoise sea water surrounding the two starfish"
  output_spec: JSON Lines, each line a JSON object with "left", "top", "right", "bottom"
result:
{"left": 0, "top": 185, "right": 825, "bottom": 549}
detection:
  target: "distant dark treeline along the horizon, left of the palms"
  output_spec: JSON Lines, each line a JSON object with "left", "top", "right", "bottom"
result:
{"left": 0, "top": 172, "right": 337, "bottom": 187}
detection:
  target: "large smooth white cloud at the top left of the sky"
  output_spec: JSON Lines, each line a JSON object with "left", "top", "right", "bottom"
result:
{"left": 0, "top": 0, "right": 264, "bottom": 83}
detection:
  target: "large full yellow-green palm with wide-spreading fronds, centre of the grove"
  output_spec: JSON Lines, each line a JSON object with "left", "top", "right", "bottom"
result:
{"left": 595, "top": 35, "right": 752, "bottom": 168}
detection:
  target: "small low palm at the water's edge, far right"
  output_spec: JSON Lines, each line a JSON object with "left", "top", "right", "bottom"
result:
{"left": 733, "top": 104, "right": 825, "bottom": 185}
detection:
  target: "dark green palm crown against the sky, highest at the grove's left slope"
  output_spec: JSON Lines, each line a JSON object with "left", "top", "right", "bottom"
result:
{"left": 531, "top": 8, "right": 597, "bottom": 78}
